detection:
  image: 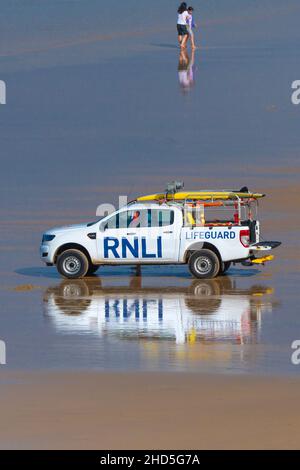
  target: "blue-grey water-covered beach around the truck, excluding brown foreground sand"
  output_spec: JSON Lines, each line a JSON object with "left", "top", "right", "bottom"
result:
{"left": 0, "top": 0, "right": 300, "bottom": 374}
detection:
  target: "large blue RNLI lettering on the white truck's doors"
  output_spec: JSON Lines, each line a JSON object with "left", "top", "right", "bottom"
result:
{"left": 103, "top": 237, "right": 162, "bottom": 259}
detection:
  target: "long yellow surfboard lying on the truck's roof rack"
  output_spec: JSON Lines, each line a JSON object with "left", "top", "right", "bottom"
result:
{"left": 136, "top": 191, "right": 265, "bottom": 202}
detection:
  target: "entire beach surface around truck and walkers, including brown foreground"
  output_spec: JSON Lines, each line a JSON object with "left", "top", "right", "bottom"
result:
{"left": 0, "top": 0, "right": 300, "bottom": 449}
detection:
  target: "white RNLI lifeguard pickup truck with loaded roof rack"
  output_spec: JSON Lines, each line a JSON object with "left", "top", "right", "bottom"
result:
{"left": 40, "top": 183, "right": 280, "bottom": 279}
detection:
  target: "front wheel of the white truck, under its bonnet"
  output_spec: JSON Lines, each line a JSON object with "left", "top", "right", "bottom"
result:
{"left": 56, "top": 249, "right": 89, "bottom": 279}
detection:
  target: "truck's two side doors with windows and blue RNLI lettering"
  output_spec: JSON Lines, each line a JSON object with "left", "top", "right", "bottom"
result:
{"left": 98, "top": 208, "right": 179, "bottom": 263}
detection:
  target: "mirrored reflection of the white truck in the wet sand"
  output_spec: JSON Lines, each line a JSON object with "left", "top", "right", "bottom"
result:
{"left": 44, "top": 277, "right": 272, "bottom": 344}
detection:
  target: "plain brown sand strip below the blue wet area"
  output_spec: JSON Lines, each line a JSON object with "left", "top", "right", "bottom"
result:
{"left": 0, "top": 372, "right": 300, "bottom": 449}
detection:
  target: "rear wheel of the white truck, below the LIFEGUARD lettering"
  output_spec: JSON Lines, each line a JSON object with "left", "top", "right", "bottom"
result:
{"left": 189, "top": 249, "right": 220, "bottom": 279}
